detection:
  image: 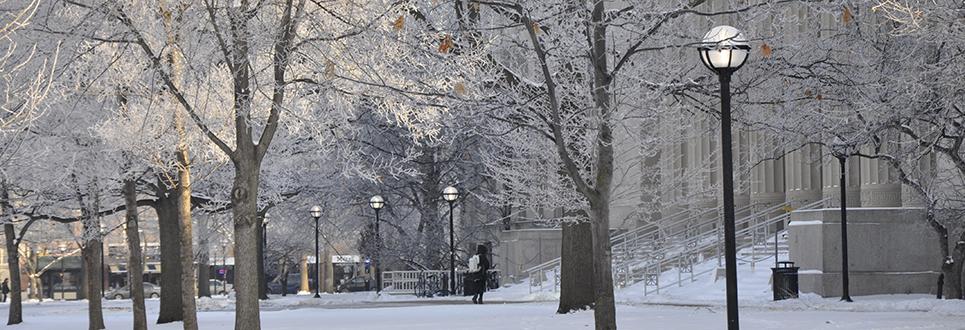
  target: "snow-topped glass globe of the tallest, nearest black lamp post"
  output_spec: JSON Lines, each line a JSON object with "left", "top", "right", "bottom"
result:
{"left": 697, "top": 25, "right": 751, "bottom": 74}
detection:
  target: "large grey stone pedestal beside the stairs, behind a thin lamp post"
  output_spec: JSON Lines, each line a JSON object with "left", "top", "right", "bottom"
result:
{"left": 788, "top": 208, "right": 942, "bottom": 297}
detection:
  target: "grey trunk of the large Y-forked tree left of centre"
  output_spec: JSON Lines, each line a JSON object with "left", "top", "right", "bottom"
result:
{"left": 231, "top": 160, "right": 261, "bottom": 330}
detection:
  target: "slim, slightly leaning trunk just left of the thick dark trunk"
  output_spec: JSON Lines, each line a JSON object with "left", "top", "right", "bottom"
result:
{"left": 124, "top": 179, "right": 147, "bottom": 330}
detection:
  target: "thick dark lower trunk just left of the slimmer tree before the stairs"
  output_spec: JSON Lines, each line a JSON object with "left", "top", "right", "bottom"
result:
{"left": 556, "top": 222, "right": 595, "bottom": 314}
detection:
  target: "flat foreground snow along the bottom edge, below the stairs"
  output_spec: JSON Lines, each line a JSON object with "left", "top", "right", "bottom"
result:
{"left": 0, "top": 295, "right": 965, "bottom": 330}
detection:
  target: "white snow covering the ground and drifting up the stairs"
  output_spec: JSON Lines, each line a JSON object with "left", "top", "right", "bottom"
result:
{"left": 7, "top": 253, "right": 965, "bottom": 330}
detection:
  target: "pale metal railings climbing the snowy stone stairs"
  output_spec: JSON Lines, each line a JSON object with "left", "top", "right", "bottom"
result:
{"left": 528, "top": 200, "right": 825, "bottom": 295}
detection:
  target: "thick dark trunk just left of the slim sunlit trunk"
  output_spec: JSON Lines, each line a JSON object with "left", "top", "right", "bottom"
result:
{"left": 155, "top": 186, "right": 184, "bottom": 324}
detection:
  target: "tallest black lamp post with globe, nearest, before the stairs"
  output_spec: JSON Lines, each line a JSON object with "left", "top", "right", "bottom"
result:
{"left": 698, "top": 25, "right": 751, "bottom": 330}
